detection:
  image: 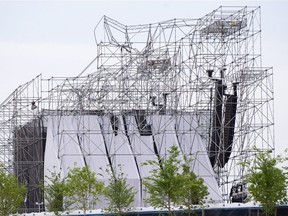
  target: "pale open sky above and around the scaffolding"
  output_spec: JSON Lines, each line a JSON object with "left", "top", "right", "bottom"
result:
{"left": 0, "top": 0, "right": 288, "bottom": 152}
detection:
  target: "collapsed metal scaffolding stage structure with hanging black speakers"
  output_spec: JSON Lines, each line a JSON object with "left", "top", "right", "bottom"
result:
{"left": 0, "top": 7, "right": 274, "bottom": 211}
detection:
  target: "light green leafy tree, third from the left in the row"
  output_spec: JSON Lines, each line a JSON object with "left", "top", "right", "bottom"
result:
{"left": 64, "top": 166, "right": 104, "bottom": 215}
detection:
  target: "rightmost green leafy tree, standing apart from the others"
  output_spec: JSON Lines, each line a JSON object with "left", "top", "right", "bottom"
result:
{"left": 246, "top": 149, "right": 287, "bottom": 215}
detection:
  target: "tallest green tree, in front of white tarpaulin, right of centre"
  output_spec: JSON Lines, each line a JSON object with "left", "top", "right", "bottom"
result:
{"left": 143, "top": 146, "right": 183, "bottom": 215}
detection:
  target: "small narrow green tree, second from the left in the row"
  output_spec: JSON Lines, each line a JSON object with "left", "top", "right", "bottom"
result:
{"left": 41, "top": 172, "right": 66, "bottom": 215}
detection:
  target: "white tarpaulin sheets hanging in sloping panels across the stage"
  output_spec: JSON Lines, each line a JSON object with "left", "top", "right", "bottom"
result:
{"left": 44, "top": 114, "right": 221, "bottom": 206}
